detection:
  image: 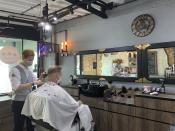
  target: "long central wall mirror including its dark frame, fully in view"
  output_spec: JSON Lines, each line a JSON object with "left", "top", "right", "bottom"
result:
{"left": 75, "top": 47, "right": 141, "bottom": 81}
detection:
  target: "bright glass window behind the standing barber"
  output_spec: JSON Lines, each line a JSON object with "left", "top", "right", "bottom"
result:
{"left": 0, "top": 37, "right": 38, "bottom": 93}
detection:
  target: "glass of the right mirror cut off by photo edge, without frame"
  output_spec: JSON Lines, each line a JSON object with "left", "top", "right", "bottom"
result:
{"left": 148, "top": 47, "right": 175, "bottom": 78}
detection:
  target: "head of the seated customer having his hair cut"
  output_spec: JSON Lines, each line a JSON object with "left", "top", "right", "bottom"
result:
{"left": 47, "top": 66, "right": 61, "bottom": 83}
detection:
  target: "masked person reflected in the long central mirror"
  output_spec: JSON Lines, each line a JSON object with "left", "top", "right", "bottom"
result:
{"left": 112, "top": 59, "right": 122, "bottom": 76}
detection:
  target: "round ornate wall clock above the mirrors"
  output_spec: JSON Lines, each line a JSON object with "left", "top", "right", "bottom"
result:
{"left": 131, "top": 14, "right": 155, "bottom": 37}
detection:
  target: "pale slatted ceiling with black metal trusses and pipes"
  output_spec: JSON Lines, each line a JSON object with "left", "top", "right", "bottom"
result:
{"left": 0, "top": 0, "right": 136, "bottom": 26}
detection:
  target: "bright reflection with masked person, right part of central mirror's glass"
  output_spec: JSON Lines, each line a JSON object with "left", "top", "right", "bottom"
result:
{"left": 97, "top": 51, "right": 137, "bottom": 77}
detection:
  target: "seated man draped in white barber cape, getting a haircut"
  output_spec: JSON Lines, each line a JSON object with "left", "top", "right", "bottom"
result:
{"left": 22, "top": 66, "right": 92, "bottom": 131}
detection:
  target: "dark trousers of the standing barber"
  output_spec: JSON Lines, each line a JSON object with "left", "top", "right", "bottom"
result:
{"left": 12, "top": 101, "right": 34, "bottom": 131}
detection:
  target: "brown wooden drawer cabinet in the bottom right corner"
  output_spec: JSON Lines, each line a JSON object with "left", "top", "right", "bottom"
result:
{"left": 135, "top": 94, "right": 175, "bottom": 131}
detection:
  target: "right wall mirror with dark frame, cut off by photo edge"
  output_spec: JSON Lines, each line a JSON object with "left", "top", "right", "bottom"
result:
{"left": 146, "top": 42, "right": 175, "bottom": 83}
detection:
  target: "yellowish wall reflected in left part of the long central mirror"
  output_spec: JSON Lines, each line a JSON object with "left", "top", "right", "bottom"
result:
{"left": 81, "top": 54, "right": 97, "bottom": 75}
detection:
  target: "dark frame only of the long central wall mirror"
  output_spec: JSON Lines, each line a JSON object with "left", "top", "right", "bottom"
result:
{"left": 75, "top": 46, "right": 142, "bottom": 82}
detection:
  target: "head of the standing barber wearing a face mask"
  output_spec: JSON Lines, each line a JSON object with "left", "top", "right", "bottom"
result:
{"left": 22, "top": 49, "right": 35, "bottom": 66}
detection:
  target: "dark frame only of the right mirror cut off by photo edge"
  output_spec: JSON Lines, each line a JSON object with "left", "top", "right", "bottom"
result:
{"left": 142, "top": 42, "right": 175, "bottom": 84}
